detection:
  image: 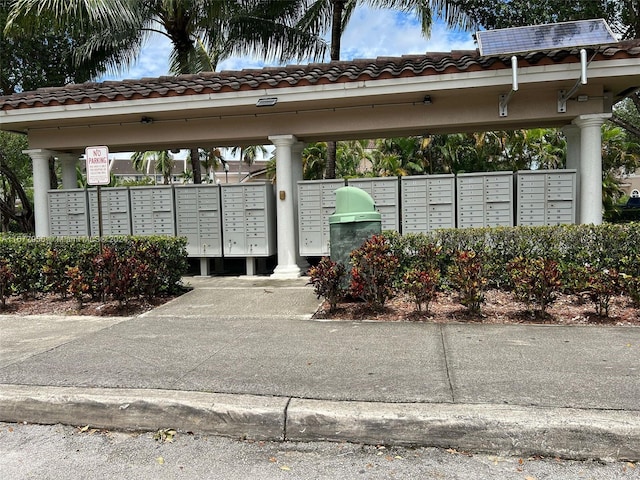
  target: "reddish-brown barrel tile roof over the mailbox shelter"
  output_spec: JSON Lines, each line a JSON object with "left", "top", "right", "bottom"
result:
{"left": 0, "top": 40, "right": 640, "bottom": 110}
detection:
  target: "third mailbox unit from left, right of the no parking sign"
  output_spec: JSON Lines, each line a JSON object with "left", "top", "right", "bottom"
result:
{"left": 129, "top": 185, "right": 176, "bottom": 235}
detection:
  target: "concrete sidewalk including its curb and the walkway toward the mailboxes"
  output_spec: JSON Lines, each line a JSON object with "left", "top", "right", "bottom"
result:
{"left": 0, "top": 277, "right": 640, "bottom": 460}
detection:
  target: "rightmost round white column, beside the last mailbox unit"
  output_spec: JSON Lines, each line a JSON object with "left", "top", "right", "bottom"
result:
{"left": 573, "top": 113, "right": 611, "bottom": 225}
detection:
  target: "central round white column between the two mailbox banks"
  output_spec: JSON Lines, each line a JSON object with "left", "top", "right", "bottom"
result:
{"left": 269, "top": 135, "right": 300, "bottom": 279}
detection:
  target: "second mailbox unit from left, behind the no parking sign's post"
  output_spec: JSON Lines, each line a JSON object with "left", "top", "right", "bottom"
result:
{"left": 87, "top": 187, "right": 131, "bottom": 237}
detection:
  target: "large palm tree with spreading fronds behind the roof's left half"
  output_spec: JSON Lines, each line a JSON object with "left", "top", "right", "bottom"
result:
{"left": 7, "top": 0, "right": 326, "bottom": 183}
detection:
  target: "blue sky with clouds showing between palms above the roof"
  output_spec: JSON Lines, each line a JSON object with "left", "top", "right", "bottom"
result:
{"left": 104, "top": 7, "right": 475, "bottom": 80}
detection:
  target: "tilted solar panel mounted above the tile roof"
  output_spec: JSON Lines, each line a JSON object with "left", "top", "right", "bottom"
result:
{"left": 476, "top": 18, "right": 617, "bottom": 56}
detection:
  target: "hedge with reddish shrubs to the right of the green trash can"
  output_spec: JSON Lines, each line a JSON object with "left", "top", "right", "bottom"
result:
{"left": 308, "top": 223, "right": 640, "bottom": 315}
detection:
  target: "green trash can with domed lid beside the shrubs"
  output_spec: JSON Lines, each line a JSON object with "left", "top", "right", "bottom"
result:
{"left": 329, "top": 187, "right": 382, "bottom": 271}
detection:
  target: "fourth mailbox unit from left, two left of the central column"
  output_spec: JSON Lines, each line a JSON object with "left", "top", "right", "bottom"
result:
{"left": 174, "top": 184, "right": 222, "bottom": 257}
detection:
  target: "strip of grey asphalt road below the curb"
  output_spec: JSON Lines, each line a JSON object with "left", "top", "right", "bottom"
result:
{"left": 0, "top": 423, "right": 640, "bottom": 480}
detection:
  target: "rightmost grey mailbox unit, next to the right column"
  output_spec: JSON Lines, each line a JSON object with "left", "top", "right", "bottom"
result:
{"left": 516, "top": 170, "right": 576, "bottom": 225}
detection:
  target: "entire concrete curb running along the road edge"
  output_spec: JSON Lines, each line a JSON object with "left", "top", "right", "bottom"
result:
{"left": 0, "top": 385, "right": 640, "bottom": 461}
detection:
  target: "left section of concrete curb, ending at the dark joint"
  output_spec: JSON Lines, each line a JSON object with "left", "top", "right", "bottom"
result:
{"left": 0, "top": 385, "right": 289, "bottom": 440}
